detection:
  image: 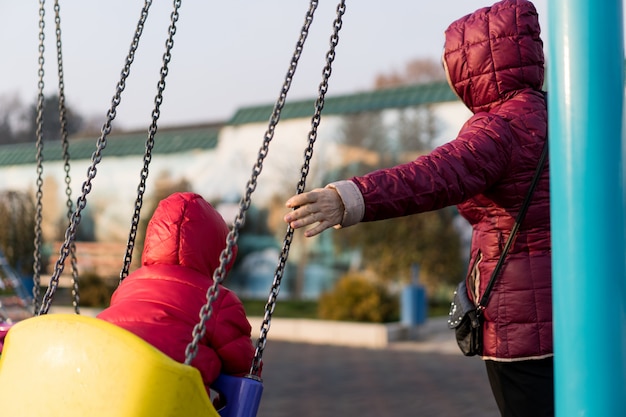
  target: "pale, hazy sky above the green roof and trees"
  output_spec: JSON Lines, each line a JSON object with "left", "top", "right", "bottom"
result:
{"left": 0, "top": 0, "right": 548, "bottom": 129}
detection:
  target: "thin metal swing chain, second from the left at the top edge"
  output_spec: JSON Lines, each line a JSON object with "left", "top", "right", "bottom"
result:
{"left": 54, "top": 0, "right": 80, "bottom": 314}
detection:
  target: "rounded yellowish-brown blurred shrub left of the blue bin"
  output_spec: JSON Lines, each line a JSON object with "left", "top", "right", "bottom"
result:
{"left": 318, "top": 272, "right": 399, "bottom": 323}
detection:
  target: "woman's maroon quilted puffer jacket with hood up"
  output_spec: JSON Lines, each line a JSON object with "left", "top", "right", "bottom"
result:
{"left": 352, "top": 0, "right": 552, "bottom": 361}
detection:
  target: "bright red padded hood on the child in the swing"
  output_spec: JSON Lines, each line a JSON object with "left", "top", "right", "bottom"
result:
{"left": 142, "top": 192, "right": 237, "bottom": 277}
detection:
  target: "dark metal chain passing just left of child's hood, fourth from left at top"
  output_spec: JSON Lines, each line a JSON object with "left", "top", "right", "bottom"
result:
{"left": 120, "top": 0, "right": 181, "bottom": 283}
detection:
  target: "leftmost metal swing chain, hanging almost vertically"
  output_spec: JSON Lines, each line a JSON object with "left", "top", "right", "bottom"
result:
{"left": 33, "top": 0, "right": 46, "bottom": 314}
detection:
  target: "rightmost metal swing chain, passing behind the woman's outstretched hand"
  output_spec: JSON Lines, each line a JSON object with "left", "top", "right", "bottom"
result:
{"left": 250, "top": 0, "right": 346, "bottom": 376}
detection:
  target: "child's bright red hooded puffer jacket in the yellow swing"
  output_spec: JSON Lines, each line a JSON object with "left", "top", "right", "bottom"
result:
{"left": 98, "top": 193, "right": 254, "bottom": 386}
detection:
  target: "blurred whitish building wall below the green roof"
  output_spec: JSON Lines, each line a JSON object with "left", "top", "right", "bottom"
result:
{"left": 0, "top": 102, "right": 470, "bottom": 241}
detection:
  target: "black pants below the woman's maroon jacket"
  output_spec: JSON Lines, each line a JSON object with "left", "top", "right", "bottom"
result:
{"left": 485, "top": 358, "right": 554, "bottom": 417}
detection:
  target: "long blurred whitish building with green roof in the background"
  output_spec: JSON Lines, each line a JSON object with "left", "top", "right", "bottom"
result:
{"left": 0, "top": 82, "right": 468, "bottom": 240}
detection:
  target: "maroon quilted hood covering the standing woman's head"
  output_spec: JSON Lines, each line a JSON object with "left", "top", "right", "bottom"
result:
{"left": 443, "top": 0, "right": 544, "bottom": 113}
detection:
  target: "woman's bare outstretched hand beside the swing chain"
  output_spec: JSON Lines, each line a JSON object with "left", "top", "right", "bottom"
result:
{"left": 284, "top": 188, "right": 344, "bottom": 237}
